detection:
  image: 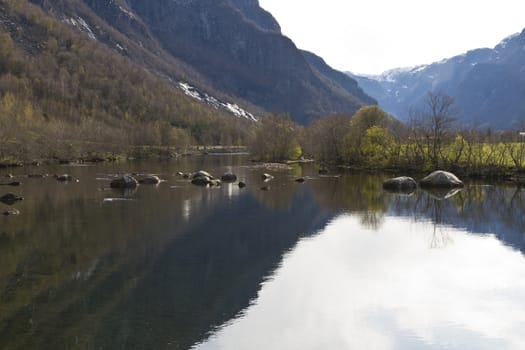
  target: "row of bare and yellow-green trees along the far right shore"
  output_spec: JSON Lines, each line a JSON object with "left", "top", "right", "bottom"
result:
{"left": 250, "top": 92, "right": 525, "bottom": 176}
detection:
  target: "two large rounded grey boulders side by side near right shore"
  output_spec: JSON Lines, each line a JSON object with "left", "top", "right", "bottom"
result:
{"left": 383, "top": 170, "right": 464, "bottom": 193}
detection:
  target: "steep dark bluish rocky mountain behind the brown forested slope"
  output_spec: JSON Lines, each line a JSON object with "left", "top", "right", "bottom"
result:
{"left": 31, "top": 0, "right": 375, "bottom": 124}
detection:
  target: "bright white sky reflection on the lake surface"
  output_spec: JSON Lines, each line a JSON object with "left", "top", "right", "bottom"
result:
{"left": 194, "top": 215, "right": 525, "bottom": 350}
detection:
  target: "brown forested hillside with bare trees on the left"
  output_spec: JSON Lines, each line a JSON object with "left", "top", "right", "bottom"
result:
{"left": 0, "top": 0, "right": 250, "bottom": 161}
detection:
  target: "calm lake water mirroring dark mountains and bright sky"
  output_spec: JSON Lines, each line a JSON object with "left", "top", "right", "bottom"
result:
{"left": 0, "top": 156, "right": 525, "bottom": 350}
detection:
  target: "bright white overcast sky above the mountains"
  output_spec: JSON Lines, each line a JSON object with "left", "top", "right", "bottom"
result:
{"left": 259, "top": 0, "right": 525, "bottom": 74}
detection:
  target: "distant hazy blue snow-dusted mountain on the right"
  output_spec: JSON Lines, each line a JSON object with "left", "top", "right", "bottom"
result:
{"left": 350, "top": 30, "right": 525, "bottom": 129}
